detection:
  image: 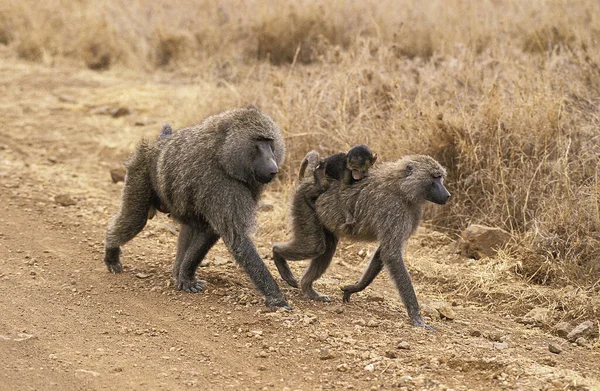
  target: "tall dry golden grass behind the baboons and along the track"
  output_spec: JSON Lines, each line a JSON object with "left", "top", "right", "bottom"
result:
{"left": 0, "top": 0, "right": 600, "bottom": 290}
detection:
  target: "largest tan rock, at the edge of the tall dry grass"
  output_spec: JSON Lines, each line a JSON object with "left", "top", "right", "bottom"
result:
{"left": 459, "top": 224, "right": 510, "bottom": 259}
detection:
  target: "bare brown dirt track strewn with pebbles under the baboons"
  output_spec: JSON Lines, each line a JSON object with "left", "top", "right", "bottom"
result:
{"left": 0, "top": 56, "right": 600, "bottom": 390}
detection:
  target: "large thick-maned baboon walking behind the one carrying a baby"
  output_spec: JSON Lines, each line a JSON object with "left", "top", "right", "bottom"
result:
{"left": 104, "top": 107, "right": 290, "bottom": 309}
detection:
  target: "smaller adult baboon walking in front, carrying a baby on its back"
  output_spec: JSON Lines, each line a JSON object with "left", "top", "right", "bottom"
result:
{"left": 273, "top": 155, "right": 450, "bottom": 329}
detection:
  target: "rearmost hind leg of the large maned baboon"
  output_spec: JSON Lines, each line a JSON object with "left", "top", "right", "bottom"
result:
{"left": 104, "top": 170, "right": 152, "bottom": 273}
